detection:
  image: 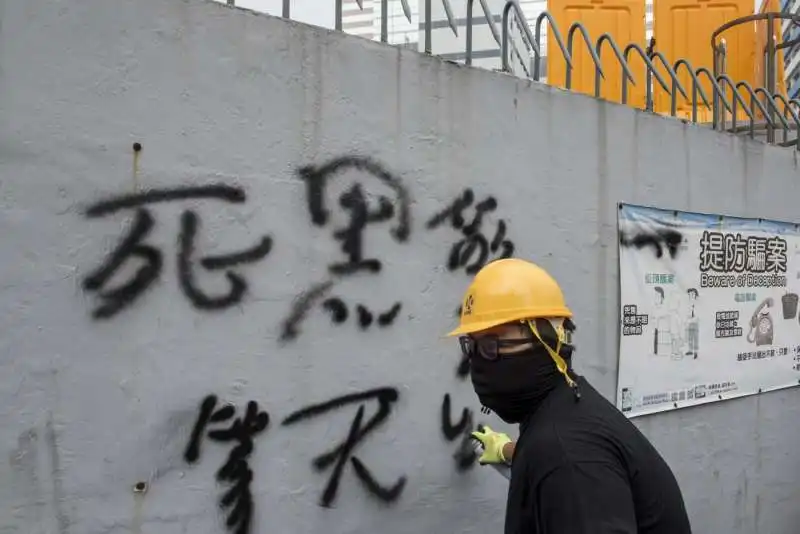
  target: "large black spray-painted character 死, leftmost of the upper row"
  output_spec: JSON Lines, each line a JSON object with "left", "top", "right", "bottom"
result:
{"left": 83, "top": 184, "right": 272, "bottom": 319}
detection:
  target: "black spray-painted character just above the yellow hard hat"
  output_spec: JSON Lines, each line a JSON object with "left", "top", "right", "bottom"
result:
{"left": 426, "top": 189, "right": 514, "bottom": 275}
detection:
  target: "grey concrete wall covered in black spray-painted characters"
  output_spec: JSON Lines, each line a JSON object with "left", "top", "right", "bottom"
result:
{"left": 0, "top": 0, "right": 800, "bottom": 534}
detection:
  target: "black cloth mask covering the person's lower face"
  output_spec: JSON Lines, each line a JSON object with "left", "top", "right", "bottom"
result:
{"left": 470, "top": 344, "right": 572, "bottom": 424}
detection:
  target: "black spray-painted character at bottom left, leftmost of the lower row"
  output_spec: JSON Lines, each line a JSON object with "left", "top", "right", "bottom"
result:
{"left": 184, "top": 395, "right": 269, "bottom": 534}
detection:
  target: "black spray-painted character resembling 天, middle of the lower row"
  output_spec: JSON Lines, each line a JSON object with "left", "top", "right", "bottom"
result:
{"left": 282, "top": 387, "right": 406, "bottom": 507}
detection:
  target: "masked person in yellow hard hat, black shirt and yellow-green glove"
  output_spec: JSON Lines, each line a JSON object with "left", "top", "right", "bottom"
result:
{"left": 449, "top": 259, "right": 691, "bottom": 534}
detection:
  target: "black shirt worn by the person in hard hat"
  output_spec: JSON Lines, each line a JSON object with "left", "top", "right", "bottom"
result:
{"left": 505, "top": 378, "right": 691, "bottom": 534}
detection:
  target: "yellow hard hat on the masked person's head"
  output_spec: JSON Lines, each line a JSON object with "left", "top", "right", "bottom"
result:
{"left": 447, "top": 258, "right": 572, "bottom": 336}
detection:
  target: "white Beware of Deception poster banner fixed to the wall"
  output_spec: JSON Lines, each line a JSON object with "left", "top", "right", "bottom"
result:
{"left": 617, "top": 204, "right": 800, "bottom": 417}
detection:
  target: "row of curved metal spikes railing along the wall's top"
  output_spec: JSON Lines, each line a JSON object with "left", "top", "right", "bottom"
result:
{"left": 226, "top": 0, "right": 800, "bottom": 151}
